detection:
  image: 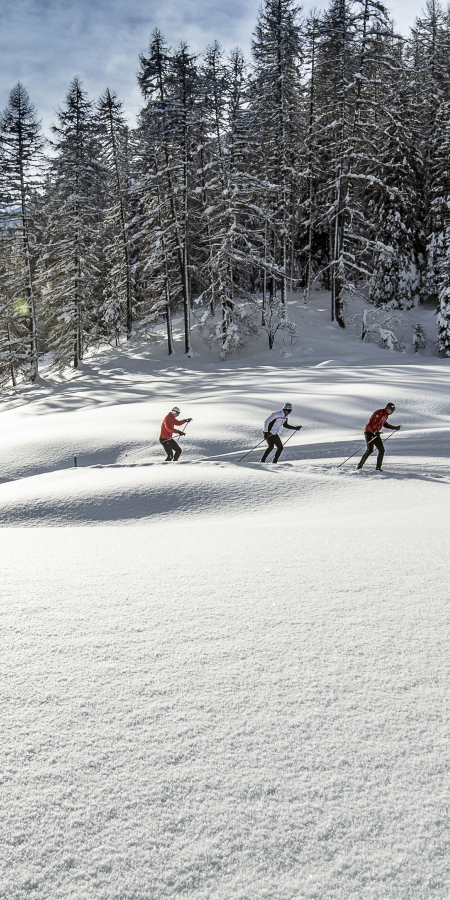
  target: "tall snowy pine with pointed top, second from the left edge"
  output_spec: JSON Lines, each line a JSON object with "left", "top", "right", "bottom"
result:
{"left": 41, "top": 78, "right": 103, "bottom": 368}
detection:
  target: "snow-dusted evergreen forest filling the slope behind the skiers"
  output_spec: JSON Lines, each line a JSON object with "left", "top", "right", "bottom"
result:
{"left": 0, "top": 0, "right": 450, "bottom": 386}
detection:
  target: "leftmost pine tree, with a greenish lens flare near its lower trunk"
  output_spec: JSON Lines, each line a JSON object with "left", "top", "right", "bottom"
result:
{"left": 0, "top": 83, "right": 44, "bottom": 381}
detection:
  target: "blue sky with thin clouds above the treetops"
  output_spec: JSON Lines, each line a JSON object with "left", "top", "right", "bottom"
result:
{"left": 0, "top": 0, "right": 425, "bottom": 132}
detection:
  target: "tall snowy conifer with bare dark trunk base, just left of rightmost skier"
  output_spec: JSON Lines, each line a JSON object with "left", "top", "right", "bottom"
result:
{"left": 315, "top": 0, "right": 404, "bottom": 326}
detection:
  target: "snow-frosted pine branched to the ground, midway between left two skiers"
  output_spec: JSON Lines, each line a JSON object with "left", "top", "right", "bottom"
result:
{"left": 196, "top": 42, "right": 254, "bottom": 357}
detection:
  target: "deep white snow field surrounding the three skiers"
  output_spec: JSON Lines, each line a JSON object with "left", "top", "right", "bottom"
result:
{"left": 0, "top": 294, "right": 450, "bottom": 900}
